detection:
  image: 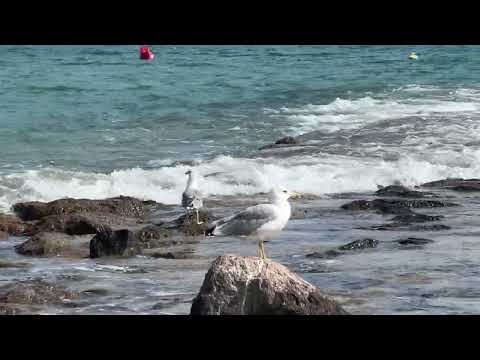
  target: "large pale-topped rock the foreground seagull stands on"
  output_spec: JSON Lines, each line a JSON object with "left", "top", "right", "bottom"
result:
{"left": 190, "top": 256, "right": 348, "bottom": 315}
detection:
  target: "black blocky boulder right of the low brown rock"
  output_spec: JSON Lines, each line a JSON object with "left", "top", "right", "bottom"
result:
{"left": 90, "top": 228, "right": 142, "bottom": 258}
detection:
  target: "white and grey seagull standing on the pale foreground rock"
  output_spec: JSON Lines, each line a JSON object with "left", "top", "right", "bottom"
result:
{"left": 205, "top": 188, "right": 298, "bottom": 259}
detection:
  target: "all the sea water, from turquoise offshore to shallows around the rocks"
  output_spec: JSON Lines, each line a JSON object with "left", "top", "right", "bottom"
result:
{"left": 0, "top": 46, "right": 480, "bottom": 314}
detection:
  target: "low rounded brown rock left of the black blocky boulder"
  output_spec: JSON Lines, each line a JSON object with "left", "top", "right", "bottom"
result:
{"left": 15, "top": 232, "right": 77, "bottom": 256}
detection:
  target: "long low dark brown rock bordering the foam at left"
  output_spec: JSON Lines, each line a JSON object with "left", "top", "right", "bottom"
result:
{"left": 13, "top": 196, "right": 156, "bottom": 221}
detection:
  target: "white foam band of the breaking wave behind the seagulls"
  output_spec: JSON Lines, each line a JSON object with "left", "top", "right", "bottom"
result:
{"left": 0, "top": 148, "right": 480, "bottom": 211}
